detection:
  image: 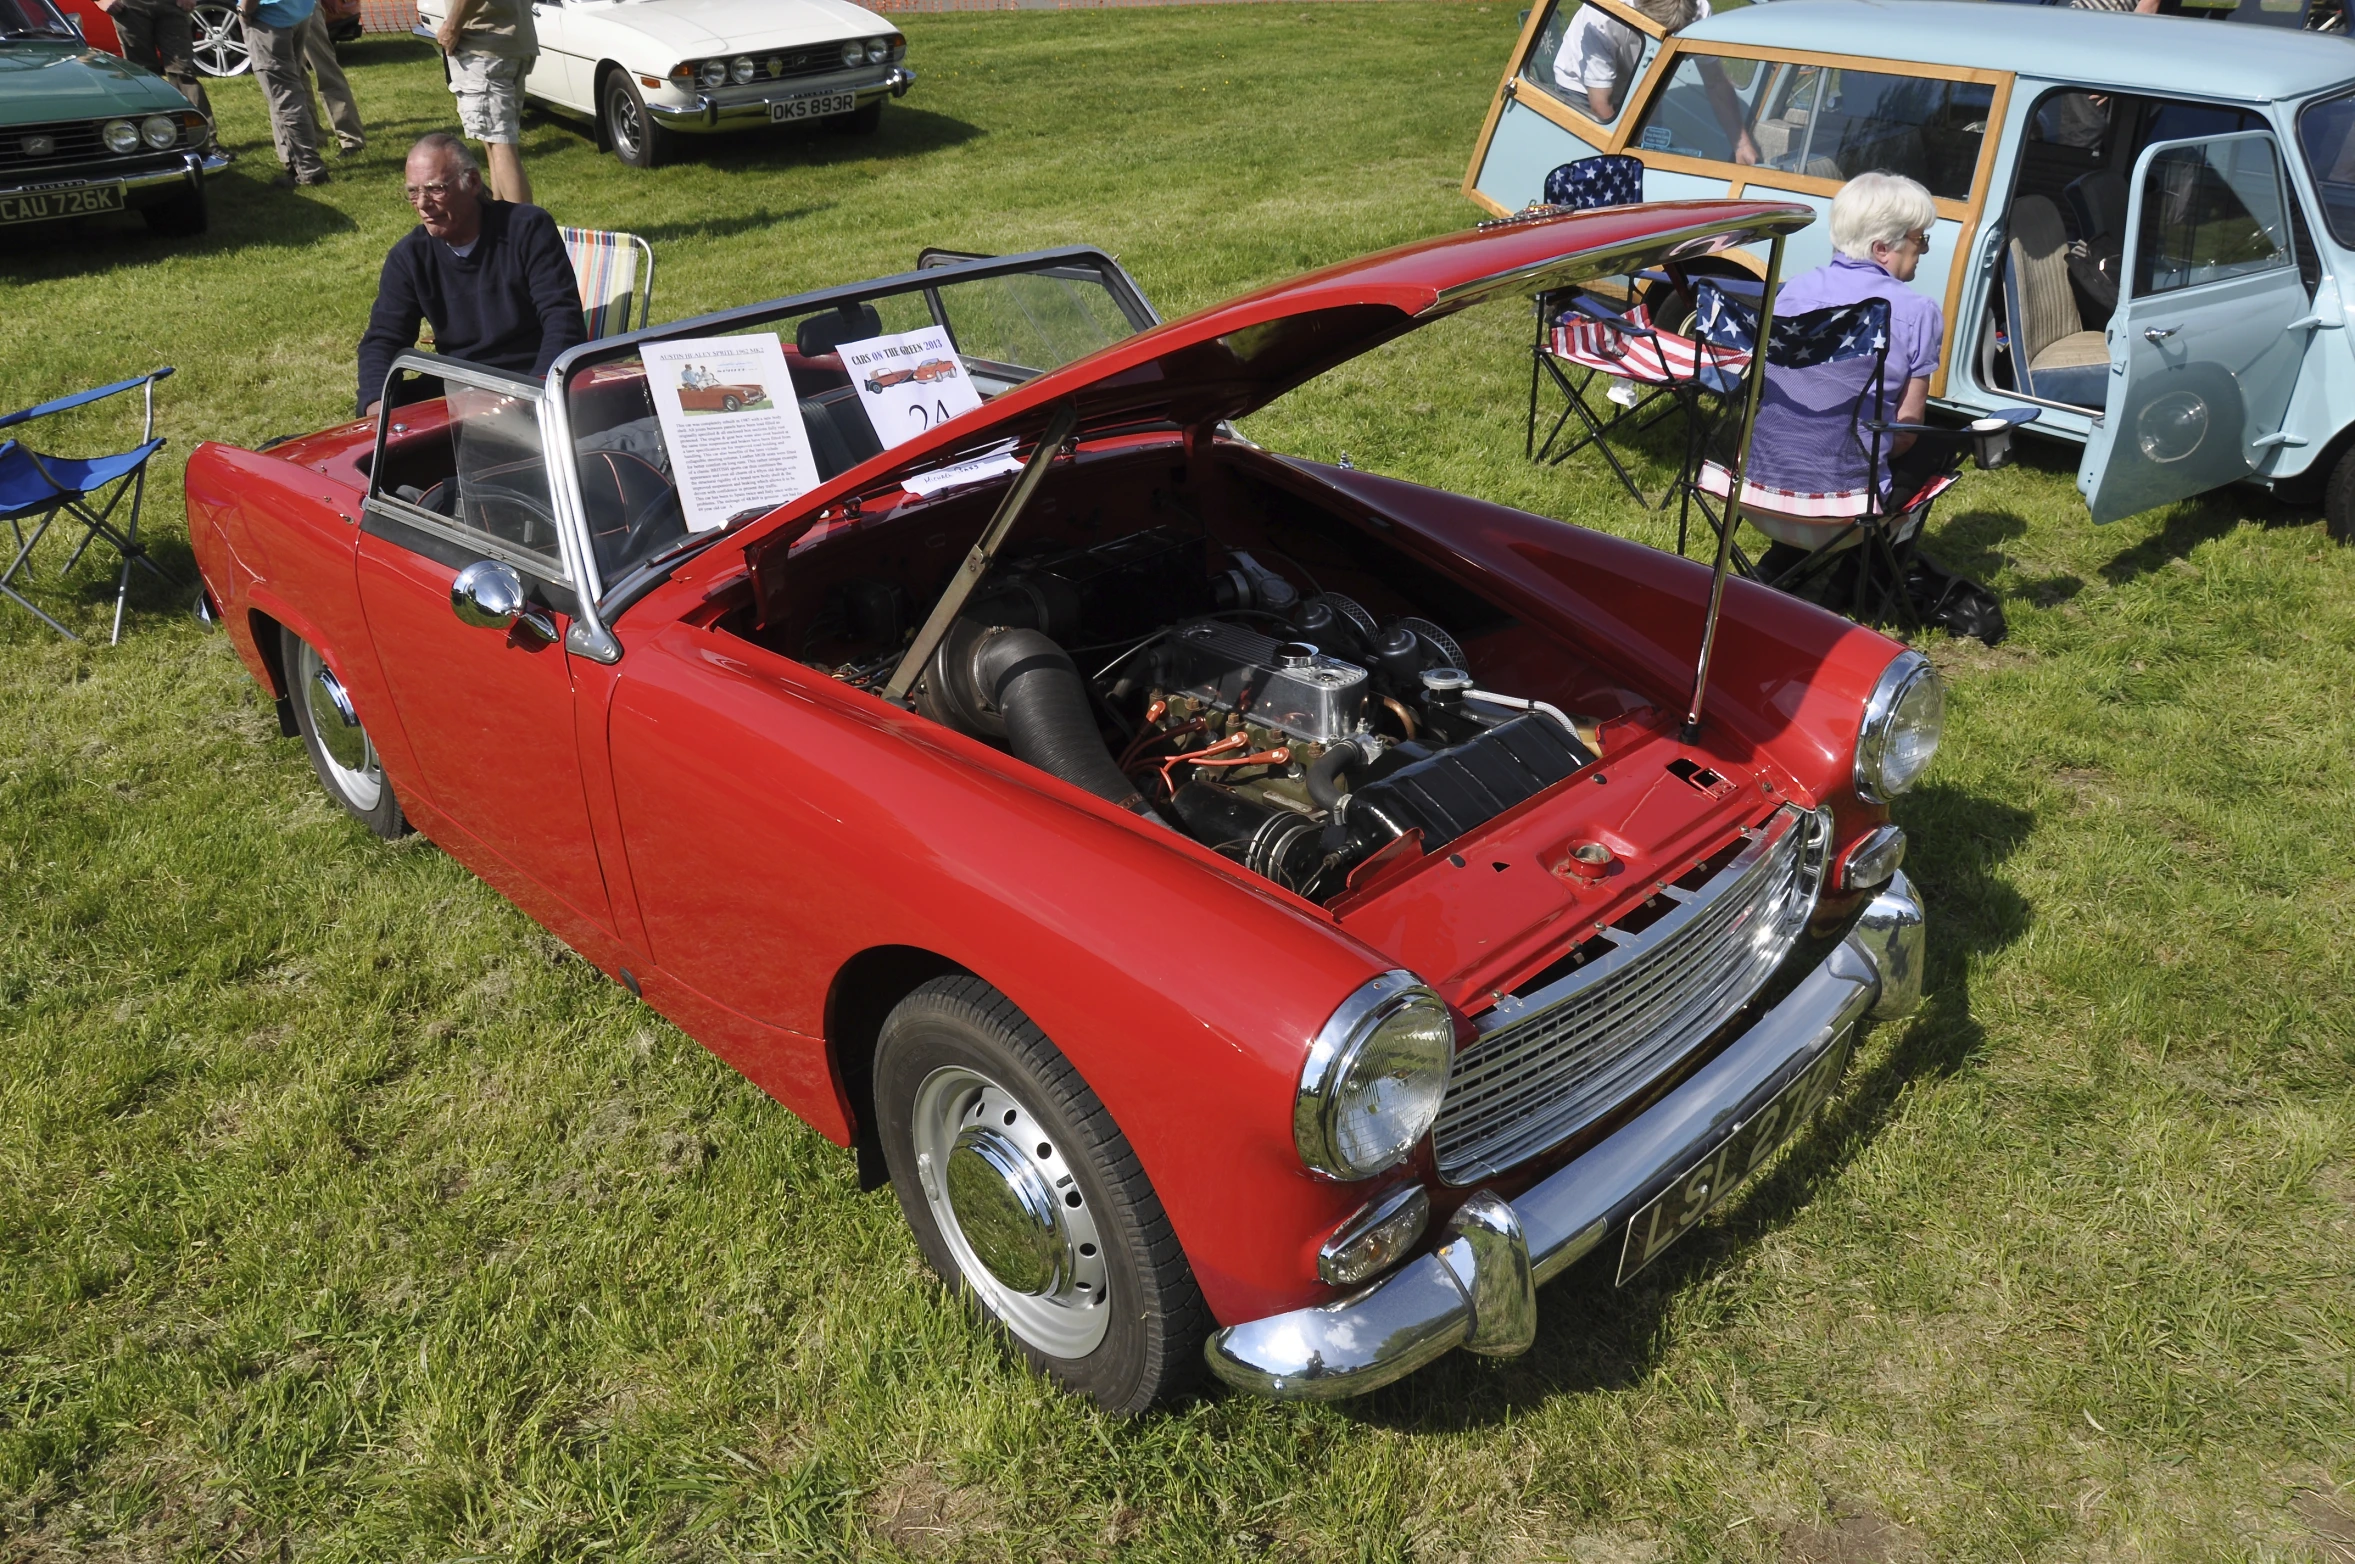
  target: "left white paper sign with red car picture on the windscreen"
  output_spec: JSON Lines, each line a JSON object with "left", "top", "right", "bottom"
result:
{"left": 645, "top": 337, "right": 817, "bottom": 532}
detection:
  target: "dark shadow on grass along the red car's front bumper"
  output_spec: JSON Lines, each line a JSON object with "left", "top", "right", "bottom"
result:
{"left": 1340, "top": 784, "right": 2035, "bottom": 1432}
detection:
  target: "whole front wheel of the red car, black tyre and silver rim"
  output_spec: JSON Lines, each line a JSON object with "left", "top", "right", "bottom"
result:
{"left": 874, "top": 978, "right": 1210, "bottom": 1416}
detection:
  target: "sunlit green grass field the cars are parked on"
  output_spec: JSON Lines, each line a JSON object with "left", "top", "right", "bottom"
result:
{"left": 0, "top": 5, "right": 2355, "bottom": 1564}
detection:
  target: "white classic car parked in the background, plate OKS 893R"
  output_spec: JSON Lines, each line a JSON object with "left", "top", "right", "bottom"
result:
{"left": 417, "top": 0, "right": 916, "bottom": 167}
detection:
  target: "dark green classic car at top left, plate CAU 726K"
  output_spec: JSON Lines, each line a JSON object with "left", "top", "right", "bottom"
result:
{"left": 0, "top": 0, "right": 228, "bottom": 233}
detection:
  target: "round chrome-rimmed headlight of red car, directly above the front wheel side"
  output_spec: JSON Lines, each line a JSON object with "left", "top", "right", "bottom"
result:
{"left": 1293, "top": 973, "right": 1455, "bottom": 1180}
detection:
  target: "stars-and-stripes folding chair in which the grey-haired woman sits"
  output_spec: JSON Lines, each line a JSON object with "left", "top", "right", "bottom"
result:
{"left": 1689, "top": 280, "right": 2037, "bottom": 643}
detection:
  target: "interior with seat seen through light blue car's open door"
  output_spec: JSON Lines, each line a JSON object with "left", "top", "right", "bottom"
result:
{"left": 1978, "top": 90, "right": 2320, "bottom": 412}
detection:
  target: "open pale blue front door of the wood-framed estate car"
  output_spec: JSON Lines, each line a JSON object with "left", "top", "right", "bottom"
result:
{"left": 2077, "top": 130, "right": 2310, "bottom": 521}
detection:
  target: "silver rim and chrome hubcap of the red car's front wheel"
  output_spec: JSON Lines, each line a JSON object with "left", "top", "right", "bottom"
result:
{"left": 909, "top": 1067, "right": 1112, "bottom": 1357}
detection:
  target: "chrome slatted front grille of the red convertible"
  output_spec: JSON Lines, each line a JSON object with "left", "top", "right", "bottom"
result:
{"left": 1432, "top": 806, "right": 1830, "bottom": 1185}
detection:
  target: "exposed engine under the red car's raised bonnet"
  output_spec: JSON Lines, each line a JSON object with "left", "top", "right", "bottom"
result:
{"left": 836, "top": 528, "right": 1594, "bottom": 902}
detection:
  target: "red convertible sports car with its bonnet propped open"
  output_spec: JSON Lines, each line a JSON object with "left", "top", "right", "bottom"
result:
{"left": 188, "top": 203, "right": 1943, "bottom": 1411}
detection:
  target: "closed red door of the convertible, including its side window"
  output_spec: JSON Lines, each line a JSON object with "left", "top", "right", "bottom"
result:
{"left": 358, "top": 356, "right": 612, "bottom": 933}
